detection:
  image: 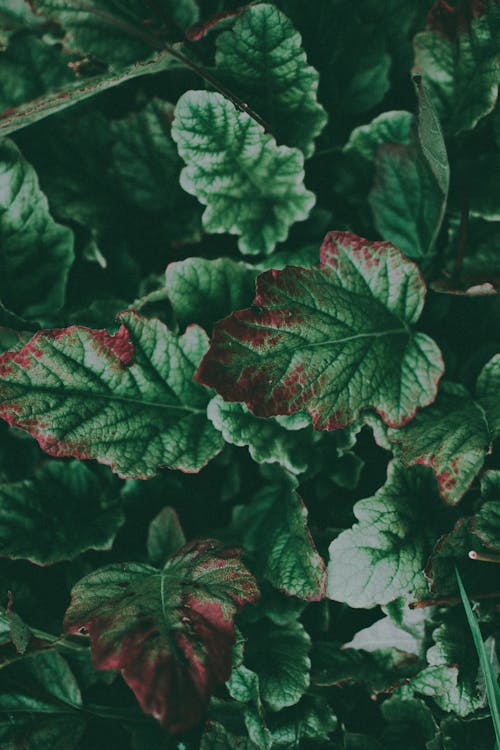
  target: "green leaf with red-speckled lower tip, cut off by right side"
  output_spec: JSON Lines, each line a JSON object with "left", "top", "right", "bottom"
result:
{"left": 390, "top": 355, "right": 500, "bottom": 505}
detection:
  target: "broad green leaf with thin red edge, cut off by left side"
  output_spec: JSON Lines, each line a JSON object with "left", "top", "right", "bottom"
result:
{"left": 0, "top": 312, "right": 223, "bottom": 477}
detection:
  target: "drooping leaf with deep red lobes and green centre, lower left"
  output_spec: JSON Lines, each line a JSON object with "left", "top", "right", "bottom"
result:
{"left": 65, "top": 539, "right": 259, "bottom": 732}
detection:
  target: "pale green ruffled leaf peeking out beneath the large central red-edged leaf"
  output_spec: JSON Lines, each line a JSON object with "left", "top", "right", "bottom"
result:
{"left": 207, "top": 396, "right": 314, "bottom": 474}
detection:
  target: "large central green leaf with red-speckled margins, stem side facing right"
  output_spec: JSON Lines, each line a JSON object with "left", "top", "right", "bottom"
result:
{"left": 195, "top": 232, "right": 443, "bottom": 430}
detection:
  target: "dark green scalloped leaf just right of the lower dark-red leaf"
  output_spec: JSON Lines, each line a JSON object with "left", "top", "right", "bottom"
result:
{"left": 245, "top": 620, "right": 311, "bottom": 711}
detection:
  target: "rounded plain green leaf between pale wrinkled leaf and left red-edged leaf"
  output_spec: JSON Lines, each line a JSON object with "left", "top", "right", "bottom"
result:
{"left": 165, "top": 258, "right": 258, "bottom": 330}
